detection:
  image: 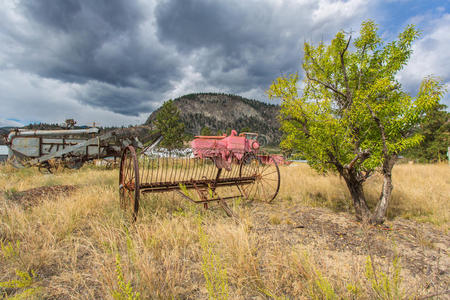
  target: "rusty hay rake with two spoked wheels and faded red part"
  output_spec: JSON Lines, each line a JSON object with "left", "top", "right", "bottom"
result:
{"left": 119, "top": 130, "right": 280, "bottom": 220}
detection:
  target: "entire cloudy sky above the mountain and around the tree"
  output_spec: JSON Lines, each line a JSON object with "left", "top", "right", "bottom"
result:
{"left": 0, "top": 0, "right": 450, "bottom": 127}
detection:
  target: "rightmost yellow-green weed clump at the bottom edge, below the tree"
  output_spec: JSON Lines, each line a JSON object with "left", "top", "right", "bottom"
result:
{"left": 365, "top": 257, "right": 403, "bottom": 300}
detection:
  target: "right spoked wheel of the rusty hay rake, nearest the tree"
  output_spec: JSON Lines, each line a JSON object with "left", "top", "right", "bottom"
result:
{"left": 239, "top": 153, "right": 280, "bottom": 202}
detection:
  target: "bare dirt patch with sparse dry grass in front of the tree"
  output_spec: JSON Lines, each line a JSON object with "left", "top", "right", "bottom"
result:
{"left": 252, "top": 203, "right": 450, "bottom": 297}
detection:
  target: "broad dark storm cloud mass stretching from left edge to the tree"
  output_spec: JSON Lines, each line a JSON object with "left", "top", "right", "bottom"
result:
{"left": 0, "top": 0, "right": 376, "bottom": 116}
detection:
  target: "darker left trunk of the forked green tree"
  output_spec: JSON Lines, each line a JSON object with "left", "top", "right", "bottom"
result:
{"left": 341, "top": 170, "right": 370, "bottom": 222}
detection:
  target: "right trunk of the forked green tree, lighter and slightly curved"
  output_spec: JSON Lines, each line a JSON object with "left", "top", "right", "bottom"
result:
{"left": 370, "top": 155, "right": 397, "bottom": 224}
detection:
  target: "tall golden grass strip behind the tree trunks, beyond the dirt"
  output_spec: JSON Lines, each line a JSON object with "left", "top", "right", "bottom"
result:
{"left": 281, "top": 163, "right": 450, "bottom": 230}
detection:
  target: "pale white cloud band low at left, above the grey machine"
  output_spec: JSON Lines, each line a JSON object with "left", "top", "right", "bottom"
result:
{"left": 0, "top": 70, "right": 147, "bottom": 127}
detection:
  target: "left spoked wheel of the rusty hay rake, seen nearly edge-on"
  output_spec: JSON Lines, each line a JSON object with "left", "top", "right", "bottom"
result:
{"left": 119, "top": 146, "right": 139, "bottom": 222}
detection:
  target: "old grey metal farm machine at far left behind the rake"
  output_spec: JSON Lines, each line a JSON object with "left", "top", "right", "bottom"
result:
{"left": 6, "top": 127, "right": 142, "bottom": 172}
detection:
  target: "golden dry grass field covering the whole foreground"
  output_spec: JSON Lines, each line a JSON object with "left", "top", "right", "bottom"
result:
{"left": 0, "top": 163, "right": 450, "bottom": 299}
